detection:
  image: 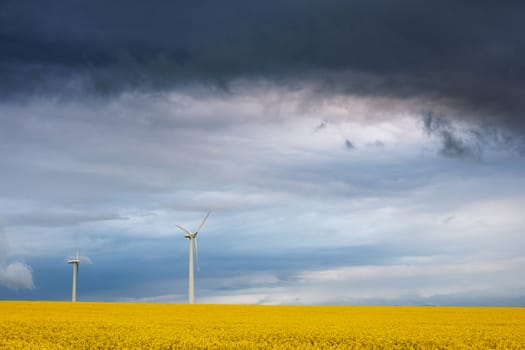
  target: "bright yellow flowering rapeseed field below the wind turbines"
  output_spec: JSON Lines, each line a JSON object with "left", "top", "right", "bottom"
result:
{"left": 0, "top": 301, "right": 525, "bottom": 350}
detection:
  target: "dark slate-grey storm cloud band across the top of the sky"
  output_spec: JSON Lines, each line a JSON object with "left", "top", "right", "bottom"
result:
{"left": 0, "top": 0, "right": 525, "bottom": 130}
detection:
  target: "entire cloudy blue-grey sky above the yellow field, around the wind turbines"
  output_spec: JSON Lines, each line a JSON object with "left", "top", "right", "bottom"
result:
{"left": 0, "top": 0, "right": 525, "bottom": 306}
